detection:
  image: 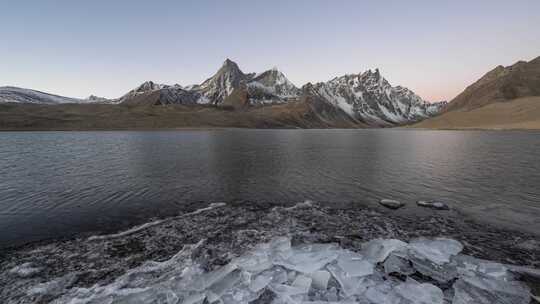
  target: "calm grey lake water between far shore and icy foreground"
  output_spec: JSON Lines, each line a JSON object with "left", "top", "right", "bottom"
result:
{"left": 0, "top": 129, "right": 540, "bottom": 246}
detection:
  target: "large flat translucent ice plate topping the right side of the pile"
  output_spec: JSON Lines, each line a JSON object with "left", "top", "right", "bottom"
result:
{"left": 409, "top": 238, "right": 463, "bottom": 265}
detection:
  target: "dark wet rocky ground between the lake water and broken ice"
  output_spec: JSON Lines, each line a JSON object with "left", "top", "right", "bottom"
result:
{"left": 0, "top": 202, "right": 540, "bottom": 303}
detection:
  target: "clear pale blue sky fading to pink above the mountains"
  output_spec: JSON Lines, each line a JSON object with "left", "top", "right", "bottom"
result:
{"left": 0, "top": 0, "right": 540, "bottom": 101}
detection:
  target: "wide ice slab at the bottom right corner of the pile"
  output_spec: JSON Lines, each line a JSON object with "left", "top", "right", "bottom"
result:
{"left": 452, "top": 274, "right": 531, "bottom": 304}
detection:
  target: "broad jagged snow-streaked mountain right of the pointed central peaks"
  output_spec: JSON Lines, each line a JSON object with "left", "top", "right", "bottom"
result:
{"left": 303, "top": 69, "right": 448, "bottom": 126}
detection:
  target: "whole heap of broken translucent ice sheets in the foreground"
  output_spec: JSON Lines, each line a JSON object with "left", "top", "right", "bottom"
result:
{"left": 20, "top": 238, "right": 530, "bottom": 304}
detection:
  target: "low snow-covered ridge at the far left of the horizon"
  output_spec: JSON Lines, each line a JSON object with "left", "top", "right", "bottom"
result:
{"left": 0, "top": 87, "right": 89, "bottom": 104}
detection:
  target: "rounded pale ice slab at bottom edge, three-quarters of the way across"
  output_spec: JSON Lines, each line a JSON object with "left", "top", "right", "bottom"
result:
{"left": 394, "top": 279, "right": 444, "bottom": 304}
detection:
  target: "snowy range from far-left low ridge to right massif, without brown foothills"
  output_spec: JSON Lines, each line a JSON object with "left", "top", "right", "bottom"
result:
{"left": 0, "top": 59, "right": 446, "bottom": 126}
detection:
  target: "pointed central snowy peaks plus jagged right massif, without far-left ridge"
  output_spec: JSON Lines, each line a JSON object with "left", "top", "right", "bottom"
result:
{"left": 120, "top": 59, "right": 445, "bottom": 126}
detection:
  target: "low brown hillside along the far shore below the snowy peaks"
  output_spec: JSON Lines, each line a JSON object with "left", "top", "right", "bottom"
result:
{"left": 0, "top": 94, "right": 367, "bottom": 130}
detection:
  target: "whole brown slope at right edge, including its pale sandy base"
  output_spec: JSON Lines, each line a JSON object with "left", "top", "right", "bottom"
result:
{"left": 413, "top": 57, "right": 540, "bottom": 129}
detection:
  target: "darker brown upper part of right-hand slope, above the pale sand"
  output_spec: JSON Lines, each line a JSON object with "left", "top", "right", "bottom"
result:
{"left": 444, "top": 57, "right": 540, "bottom": 112}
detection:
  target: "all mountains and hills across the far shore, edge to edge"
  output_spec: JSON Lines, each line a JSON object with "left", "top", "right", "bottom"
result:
{"left": 0, "top": 57, "right": 540, "bottom": 130}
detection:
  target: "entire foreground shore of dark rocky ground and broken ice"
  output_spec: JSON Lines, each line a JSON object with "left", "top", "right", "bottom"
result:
{"left": 0, "top": 202, "right": 540, "bottom": 303}
